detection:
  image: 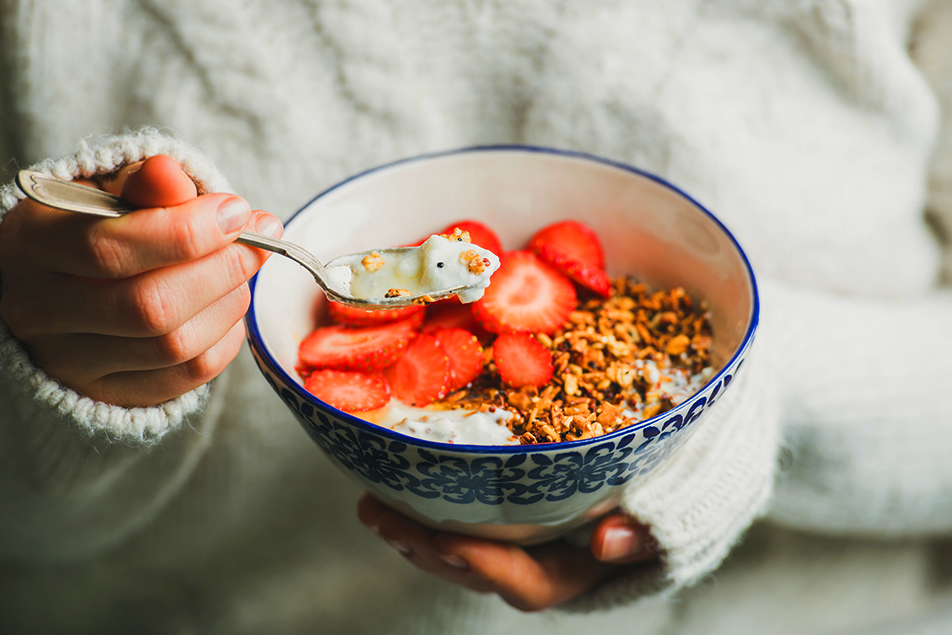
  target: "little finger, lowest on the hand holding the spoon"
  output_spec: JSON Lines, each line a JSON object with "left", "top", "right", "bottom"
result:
{"left": 87, "top": 322, "right": 245, "bottom": 408}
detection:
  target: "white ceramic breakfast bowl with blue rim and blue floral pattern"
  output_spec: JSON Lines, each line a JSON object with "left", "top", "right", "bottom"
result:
{"left": 246, "top": 146, "right": 758, "bottom": 545}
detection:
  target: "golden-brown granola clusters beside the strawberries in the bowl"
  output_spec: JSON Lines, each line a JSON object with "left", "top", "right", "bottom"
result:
{"left": 431, "top": 276, "right": 712, "bottom": 444}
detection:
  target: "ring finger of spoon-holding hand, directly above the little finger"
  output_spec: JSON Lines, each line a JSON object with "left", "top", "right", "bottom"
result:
{"left": 28, "top": 284, "right": 251, "bottom": 387}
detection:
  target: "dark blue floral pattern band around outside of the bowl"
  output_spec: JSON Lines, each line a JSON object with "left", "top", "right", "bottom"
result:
{"left": 252, "top": 340, "right": 743, "bottom": 528}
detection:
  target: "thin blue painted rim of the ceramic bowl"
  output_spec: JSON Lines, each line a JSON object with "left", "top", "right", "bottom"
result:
{"left": 245, "top": 144, "right": 760, "bottom": 454}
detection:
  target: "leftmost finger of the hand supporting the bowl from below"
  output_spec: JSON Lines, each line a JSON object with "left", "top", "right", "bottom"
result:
{"left": 357, "top": 494, "right": 491, "bottom": 593}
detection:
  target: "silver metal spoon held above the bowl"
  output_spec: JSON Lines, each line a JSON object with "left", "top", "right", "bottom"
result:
{"left": 16, "top": 170, "right": 470, "bottom": 309}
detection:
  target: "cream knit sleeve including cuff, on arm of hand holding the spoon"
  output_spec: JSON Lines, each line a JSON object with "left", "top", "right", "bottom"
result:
{"left": 0, "top": 129, "right": 236, "bottom": 560}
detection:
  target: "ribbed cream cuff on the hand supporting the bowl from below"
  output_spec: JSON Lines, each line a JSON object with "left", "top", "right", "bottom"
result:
{"left": 565, "top": 351, "right": 779, "bottom": 611}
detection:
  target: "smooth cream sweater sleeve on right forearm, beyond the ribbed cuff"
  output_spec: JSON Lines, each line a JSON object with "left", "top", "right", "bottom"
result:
{"left": 764, "top": 284, "right": 952, "bottom": 537}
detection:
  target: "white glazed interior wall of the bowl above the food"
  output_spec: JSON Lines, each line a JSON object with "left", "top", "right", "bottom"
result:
{"left": 253, "top": 149, "right": 754, "bottom": 388}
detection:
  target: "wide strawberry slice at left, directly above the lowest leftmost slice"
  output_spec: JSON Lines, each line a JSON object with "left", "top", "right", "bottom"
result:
{"left": 298, "top": 314, "right": 422, "bottom": 372}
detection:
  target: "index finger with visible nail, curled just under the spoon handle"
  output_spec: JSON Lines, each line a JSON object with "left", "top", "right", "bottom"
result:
{"left": 11, "top": 194, "right": 252, "bottom": 279}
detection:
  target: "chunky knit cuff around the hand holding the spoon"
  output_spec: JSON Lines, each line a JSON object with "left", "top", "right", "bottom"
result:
{"left": 0, "top": 128, "right": 231, "bottom": 444}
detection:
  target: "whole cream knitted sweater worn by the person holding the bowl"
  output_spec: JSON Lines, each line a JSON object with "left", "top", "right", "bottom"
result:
{"left": 0, "top": 0, "right": 952, "bottom": 633}
